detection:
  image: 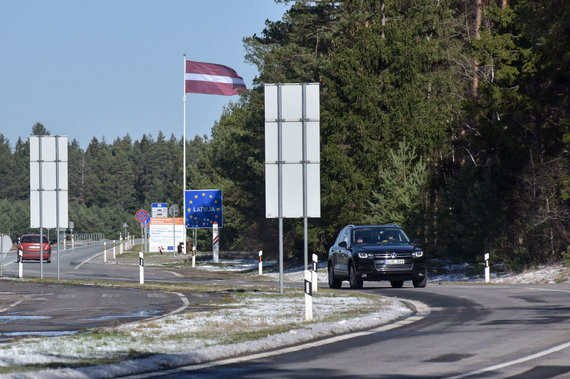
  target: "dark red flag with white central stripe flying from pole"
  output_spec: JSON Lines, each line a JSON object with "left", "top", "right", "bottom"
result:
{"left": 184, "top": 61, "right": 246, "bottom": 96}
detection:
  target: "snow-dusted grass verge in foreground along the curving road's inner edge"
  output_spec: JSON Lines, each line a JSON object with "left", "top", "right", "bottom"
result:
{"left": 0, "top": 293, "right": 411, "bottom": 378}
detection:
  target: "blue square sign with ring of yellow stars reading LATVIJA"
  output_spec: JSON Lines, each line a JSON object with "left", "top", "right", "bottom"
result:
{"left": 184, "top": 190, "right": 223, "bottom": 228}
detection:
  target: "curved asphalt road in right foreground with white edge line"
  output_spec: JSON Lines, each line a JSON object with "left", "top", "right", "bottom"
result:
{"left": 145, "top": 283, "right": 570, "bottom": 379}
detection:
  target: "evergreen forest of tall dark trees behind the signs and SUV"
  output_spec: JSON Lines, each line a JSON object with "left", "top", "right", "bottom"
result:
{"left": 0, "top": 0, "right": 570, "bottom": 267}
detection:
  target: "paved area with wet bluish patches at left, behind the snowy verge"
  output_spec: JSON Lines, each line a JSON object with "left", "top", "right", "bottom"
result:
{"left": 0, "top": 281, "right": 190, "bottom": 342}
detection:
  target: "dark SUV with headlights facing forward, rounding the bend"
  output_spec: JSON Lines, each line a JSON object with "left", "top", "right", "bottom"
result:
{"left": 328, "top": 224, "right": 427, "bottom": 288}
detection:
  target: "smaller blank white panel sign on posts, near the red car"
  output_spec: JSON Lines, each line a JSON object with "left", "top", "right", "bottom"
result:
{"left": 30, "top": 136, "right": 69, "bottom": 229}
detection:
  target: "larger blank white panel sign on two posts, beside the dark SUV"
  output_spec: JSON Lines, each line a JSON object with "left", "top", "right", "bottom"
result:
{"left": 265, "top": 83, "right": 321, "bottom": 218}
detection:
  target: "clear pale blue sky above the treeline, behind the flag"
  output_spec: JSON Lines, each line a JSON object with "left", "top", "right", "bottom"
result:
{"left": 0, "top": 0, "right": 286, "bottom": 149}
